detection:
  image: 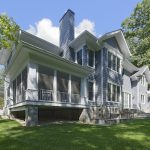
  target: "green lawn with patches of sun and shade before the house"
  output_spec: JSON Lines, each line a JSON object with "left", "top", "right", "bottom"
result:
{"left": 0, "top": 119, "right": 150, "bottom": 150}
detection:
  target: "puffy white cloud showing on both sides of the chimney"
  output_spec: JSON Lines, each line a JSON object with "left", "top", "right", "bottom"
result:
{"left": 27, "top": 18, "right": 95, "bottom": 45}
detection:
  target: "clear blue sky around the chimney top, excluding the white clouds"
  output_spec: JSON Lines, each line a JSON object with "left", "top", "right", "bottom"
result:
{"left": 0, "top": 0, "right": 141, "bottom": 35}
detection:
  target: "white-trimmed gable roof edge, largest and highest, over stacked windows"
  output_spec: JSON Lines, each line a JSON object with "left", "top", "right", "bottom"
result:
{"left": 98, "top": 29, "right": 131, "bottom": 58}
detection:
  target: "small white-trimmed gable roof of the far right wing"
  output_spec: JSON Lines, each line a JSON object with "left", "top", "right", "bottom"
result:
{"left": 131, "top": 66, "right": 150, "bottom": 83}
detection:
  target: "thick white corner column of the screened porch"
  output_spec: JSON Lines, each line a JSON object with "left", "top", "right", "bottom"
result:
{"left": 26, "top": 63, "right": 38, "bottom": 101}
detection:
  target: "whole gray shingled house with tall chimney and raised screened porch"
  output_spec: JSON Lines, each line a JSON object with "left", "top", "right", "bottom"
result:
{"left": 0, "top": 10, "right": 150, "bottom": 126}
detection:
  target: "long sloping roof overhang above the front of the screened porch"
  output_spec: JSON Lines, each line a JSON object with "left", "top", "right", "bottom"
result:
{"left": 22, "top": 42, "right": 94, "bottom": 77}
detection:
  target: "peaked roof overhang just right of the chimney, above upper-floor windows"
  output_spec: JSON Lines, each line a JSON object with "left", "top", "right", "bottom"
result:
{"left": 69, "top": 30, "right": 100, "bottom": 51}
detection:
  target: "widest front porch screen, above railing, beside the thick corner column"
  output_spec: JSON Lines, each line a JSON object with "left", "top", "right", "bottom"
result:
{"left": 38, "top": 66, "right": 54, "bottom": 90}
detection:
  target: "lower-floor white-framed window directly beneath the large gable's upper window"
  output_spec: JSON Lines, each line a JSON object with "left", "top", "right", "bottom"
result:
{"left": 107, "top": 83, "right": 120, "bottom": 102}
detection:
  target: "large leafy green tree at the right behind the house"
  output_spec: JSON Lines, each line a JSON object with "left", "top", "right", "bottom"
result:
{"left": 122, "top": 0, "right": 150, "bottom": 67}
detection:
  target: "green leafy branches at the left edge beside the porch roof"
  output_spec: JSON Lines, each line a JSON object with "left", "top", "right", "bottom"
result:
{"left": 0, "top": 14, "right": 19, "bottom": 50}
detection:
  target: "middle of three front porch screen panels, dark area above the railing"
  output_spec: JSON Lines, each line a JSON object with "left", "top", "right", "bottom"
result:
{"left": 57, "top": 71, "right": 69, "bottom": 93}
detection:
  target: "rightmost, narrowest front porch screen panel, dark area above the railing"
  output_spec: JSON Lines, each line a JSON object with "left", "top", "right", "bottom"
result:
{"left": 71, "top": 76, "right": 81, "bottom": 94}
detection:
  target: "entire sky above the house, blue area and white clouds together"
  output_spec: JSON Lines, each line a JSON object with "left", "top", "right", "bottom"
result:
{"left": 0, "top": 0, "right": 141, "bottom": 45}
